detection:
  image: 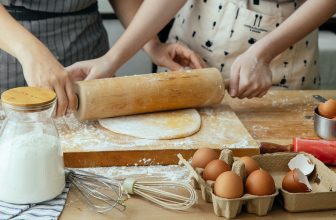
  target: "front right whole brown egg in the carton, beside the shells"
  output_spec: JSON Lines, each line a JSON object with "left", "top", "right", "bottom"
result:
{"left": 245, "top": 169, "right": 275, "bottom": 196}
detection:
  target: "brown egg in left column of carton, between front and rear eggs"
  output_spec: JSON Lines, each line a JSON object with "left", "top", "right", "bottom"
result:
{"left": 203, "top": 160, "right": 231, "bottom": 181}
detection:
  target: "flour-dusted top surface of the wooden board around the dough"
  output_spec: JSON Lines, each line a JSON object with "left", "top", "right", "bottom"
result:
{"left": 56, "top": 105, "right": 259, "bottom": 152}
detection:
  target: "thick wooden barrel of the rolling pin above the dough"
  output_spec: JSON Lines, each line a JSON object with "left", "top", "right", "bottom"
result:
{"left": 75, "top": 68, "right": 225, "bottom": 120}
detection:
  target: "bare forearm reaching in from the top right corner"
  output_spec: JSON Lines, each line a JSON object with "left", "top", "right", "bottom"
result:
{"left": 251, "top": 0, "right": 336, "bottom": 62}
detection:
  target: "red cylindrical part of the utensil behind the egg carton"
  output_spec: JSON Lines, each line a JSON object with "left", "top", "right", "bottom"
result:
{"left": 293, "top": 138, "right": 336, "bottom": 165}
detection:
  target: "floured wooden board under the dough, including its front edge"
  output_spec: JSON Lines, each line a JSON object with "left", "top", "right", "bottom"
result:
{"left": 56, "top": 104, "right": 259, "bottom": 167}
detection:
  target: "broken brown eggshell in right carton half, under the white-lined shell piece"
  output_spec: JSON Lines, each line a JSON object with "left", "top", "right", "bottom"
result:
{"left": 282, "top": 169, "right": 310, "bottom": 193}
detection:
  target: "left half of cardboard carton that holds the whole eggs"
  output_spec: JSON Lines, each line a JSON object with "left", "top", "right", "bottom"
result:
{"left": 178, "top": 149, "right": 279, "bottom": 218}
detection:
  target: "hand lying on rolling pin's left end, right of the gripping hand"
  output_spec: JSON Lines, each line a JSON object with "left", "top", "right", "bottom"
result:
{"left": 66, "top": 55, "right": 116, "bottom": 81}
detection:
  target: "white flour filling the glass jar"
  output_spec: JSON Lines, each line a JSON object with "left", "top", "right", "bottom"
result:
{"left": 0, "top": 132, "right": 65, "bottom": 204}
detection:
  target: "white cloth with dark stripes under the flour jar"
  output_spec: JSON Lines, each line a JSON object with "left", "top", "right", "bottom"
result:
{"left": 0, "top": 182, "right": 70, "bottom": 220}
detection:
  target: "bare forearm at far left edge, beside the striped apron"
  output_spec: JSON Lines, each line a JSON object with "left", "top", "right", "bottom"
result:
{"left": 0, "top": 4, "right": 45, "bottom": 62}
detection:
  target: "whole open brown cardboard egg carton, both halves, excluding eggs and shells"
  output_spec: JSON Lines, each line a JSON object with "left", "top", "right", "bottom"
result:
{"left": 179, "top": 149, "right": 336, "bottom": 218}
